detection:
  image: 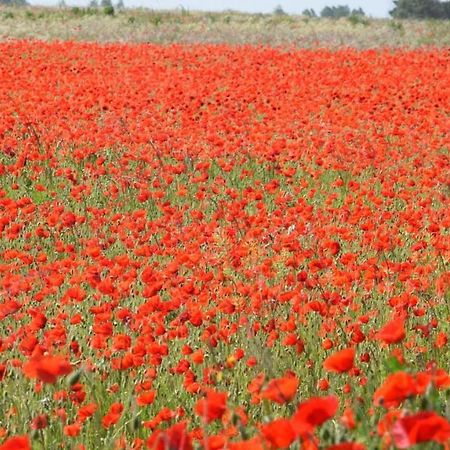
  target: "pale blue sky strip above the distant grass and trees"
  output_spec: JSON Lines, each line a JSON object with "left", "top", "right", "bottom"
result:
{"left": 30, "top": 0, "right": 393, "bottom": 17}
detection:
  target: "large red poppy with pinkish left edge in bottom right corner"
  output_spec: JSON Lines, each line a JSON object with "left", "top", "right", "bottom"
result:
{"left": 392, "top": 411, "right": 450, "bottom": 448}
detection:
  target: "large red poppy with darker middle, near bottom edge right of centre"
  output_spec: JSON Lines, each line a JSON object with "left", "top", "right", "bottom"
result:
{"left": 291, "top": 395, "right": 339, "bottom": 435}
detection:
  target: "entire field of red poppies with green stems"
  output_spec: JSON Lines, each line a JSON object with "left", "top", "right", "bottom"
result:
{"left": 0, "top": 41, "right": 450, "bottom": 450}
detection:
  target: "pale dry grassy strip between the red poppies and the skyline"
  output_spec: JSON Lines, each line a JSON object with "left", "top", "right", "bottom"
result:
{"left": 0, "top": 7, "right": 450, "bottom": 49}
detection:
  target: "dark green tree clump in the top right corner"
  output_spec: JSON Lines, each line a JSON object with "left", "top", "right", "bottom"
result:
{"left": 389, "top": 0, "right": 450, "bottom": 19}
